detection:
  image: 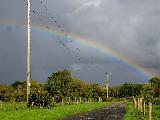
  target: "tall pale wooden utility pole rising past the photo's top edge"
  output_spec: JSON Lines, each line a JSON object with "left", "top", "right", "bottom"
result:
{"left": 27, "top": 0, "right": 31, "bottom": 103}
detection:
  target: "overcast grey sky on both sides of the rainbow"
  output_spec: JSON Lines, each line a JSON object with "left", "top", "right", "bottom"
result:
{"left": 0, "top": 0, "right": 160, "bottom": 85}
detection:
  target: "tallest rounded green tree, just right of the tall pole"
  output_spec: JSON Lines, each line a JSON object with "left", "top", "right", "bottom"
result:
{"left": 45, "top": 70, "right": 72, "bottom": 102}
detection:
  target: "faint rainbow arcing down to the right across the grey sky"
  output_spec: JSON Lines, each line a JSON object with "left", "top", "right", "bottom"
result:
{"left": 0, "top": 20, "right": 158, "bottom": 79}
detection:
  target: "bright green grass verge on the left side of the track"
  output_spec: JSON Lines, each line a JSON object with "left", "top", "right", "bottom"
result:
{"left": 0, "top": 102, "right": 111, "bottom": 120}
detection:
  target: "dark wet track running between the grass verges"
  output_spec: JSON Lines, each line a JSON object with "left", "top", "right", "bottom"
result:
{"left": 63, "top": 103, "right": 126, "bottom": 120}
